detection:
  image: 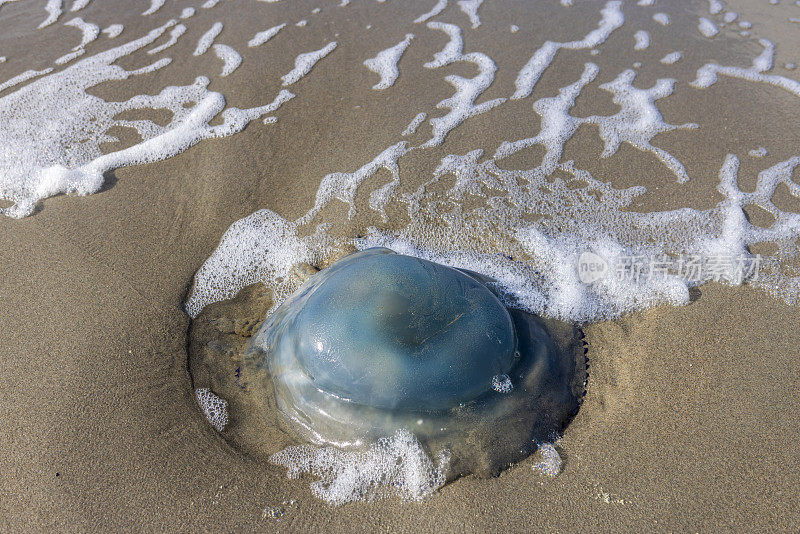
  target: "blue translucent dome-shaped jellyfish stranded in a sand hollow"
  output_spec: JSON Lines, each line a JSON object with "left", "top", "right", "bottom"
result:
{"left": 244, "top": 248, "right": 586, "bottom": 478}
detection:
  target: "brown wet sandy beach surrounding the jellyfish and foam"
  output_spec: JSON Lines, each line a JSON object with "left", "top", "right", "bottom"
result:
{"left": 0, "top": 0, "right": 800, "bottom": 532}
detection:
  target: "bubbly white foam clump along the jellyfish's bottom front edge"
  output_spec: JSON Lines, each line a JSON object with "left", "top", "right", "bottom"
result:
{"left": 271, "top": 430, "right": 449, "bottom": 505}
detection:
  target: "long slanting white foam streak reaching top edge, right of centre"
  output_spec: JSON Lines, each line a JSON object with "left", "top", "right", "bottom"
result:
{"left": 511, "top": 1, "right": 625, "bottom": 100}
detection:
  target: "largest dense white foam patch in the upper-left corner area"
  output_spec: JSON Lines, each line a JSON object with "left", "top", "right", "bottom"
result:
{"left": 0, "top": 23, "right": 293, "bottom": 217}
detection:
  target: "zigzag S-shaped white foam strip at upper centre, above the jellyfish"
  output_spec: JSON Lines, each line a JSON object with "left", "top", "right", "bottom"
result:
{"left": 422, "top": 22, "right": 506, "bottom": 147}
